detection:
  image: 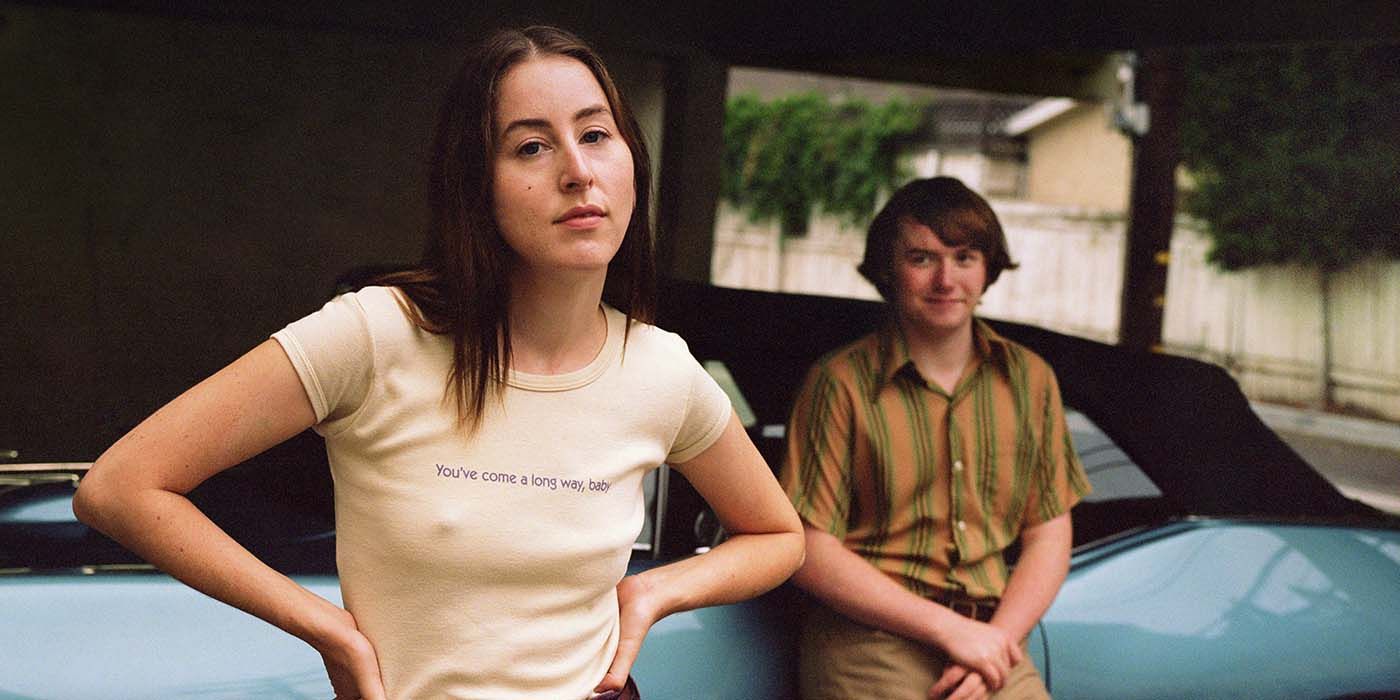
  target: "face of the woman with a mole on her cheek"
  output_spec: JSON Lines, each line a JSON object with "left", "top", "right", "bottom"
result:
{"left": 491, "top": 55, "right": 637, "bottom": 273}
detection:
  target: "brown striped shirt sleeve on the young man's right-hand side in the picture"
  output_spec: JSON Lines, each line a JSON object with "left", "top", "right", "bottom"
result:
{"left": 1022, "top": 367, "right": 1092, "bottom": 526}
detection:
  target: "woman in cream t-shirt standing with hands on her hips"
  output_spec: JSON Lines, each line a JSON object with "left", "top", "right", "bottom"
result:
{"left": 74, "top": 27, "right": 802, "bottom": 699}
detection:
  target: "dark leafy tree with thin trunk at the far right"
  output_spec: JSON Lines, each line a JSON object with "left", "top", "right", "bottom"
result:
{"left": 1182, "top": 45, "right": 1400, "bottom": 405}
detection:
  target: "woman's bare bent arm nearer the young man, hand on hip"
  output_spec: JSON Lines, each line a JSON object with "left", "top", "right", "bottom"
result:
{"left": 598, "top": 413, "right": 802, "bottom": 690}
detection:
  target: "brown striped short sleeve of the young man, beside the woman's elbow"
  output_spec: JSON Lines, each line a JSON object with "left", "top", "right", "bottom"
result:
{"left": 778, "top": 365, "right": 854, "bottom": 539}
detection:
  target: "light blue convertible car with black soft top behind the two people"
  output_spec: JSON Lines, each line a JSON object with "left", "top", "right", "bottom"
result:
{"left": 0, "top": 283, "right": 1400, "bottom": 700}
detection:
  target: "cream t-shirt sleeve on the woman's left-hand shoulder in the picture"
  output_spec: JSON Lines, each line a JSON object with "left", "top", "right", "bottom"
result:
{"left": 272, "top": 288, "right": 374, "bottom": 435}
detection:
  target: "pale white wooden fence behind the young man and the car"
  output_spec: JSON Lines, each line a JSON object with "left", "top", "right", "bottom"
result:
{"left": 711, "top": 200, "right": 1400, "bottom": 420}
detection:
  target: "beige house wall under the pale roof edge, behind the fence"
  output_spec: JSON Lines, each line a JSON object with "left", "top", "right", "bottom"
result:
{"left": 1026, "top": 102, "right": 1133, "bottom": 211}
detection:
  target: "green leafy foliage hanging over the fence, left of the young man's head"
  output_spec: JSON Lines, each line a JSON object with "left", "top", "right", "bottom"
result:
{"left": 721, "top": 92, "right": 923, "bottom": 234}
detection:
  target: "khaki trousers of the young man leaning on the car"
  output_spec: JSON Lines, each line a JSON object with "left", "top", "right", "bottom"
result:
{"left": 799, "top": 602, "right": 1050, "bottom": 700}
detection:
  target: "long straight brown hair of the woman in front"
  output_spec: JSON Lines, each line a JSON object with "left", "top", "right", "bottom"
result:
{"left": 374, "top": 27, "right": 657, "bottom": 431}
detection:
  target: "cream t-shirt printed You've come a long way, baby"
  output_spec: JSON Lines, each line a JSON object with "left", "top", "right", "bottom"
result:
{"left": 273, "top": 287, "right": 731, "bottom": 699}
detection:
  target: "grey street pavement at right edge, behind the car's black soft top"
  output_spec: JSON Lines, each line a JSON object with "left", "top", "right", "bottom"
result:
{"left": 1253, "top": 402, "right": 1400, "bottom": 514}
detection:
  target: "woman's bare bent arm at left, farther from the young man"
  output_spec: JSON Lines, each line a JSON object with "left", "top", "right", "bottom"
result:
{"left": 73, "top": 340, "right": 384, "bottom": 699}
